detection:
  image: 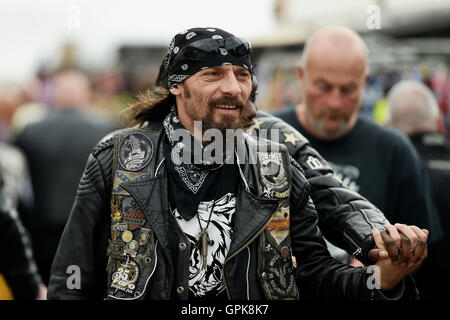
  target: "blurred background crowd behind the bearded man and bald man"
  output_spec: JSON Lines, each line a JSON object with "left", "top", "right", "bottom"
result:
{"left": 0, "top": 0, "right": 450, "bottom": 300}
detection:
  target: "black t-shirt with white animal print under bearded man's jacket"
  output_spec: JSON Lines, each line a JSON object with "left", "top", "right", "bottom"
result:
{"left": 166, "top": 138, "right": 240, "bottom": 300}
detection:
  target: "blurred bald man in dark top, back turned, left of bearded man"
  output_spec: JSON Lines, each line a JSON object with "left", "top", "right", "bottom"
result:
{"left": 14, "top": 70, "right": 118, "bottom": 284}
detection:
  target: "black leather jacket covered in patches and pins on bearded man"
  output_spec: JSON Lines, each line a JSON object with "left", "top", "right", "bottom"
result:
{"left": 48, "top": 124, "right": 412, "bottom": 300}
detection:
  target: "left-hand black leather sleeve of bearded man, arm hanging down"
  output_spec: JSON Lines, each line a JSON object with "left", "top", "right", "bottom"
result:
{"left": 47, "top": 139, "right": 113, "bottom": 300}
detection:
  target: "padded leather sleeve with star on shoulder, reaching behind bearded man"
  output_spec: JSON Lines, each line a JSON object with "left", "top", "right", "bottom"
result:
{"left": 258, "top": 112, "right": 388, "bottom": 264}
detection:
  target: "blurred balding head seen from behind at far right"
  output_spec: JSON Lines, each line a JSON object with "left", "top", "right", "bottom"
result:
{"left": 388, "top": 80, "right": 439, "bottom": 135}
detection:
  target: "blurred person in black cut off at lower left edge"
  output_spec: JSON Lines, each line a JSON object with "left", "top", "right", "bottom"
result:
{"left": 0, "top": 169, "right": 47, "bottom": 300}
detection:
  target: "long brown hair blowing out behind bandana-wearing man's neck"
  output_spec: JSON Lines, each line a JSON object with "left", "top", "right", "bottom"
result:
{"left": 120, "top": 66, "right": 175, "bottom": 128}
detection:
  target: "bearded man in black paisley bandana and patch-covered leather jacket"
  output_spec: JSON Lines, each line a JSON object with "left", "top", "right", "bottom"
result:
{"left": 48, "top": 28, "right": 426, "bottom": 300}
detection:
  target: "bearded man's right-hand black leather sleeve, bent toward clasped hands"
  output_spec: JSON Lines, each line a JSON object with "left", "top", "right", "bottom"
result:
{"left": 290, "top": 161, "right": 417, "bottom": 301}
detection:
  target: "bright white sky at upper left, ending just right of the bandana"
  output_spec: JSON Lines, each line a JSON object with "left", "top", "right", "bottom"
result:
{"left": 0, "top": 0, "right": 275, "bottom": 84}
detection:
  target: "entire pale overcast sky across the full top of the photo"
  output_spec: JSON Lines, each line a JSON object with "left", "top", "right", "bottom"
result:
{"left": 0, "top": 0, "right": 450, "bottom": 85}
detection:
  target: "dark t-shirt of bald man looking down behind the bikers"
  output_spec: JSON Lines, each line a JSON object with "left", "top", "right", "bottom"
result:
{"left": 274, "top": 108, "right": 442, "bottom": 242}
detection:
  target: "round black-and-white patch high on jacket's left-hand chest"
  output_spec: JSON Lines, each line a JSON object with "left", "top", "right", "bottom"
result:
{"left": 119, "top": 133, "right": 153, "bottom": 171}
